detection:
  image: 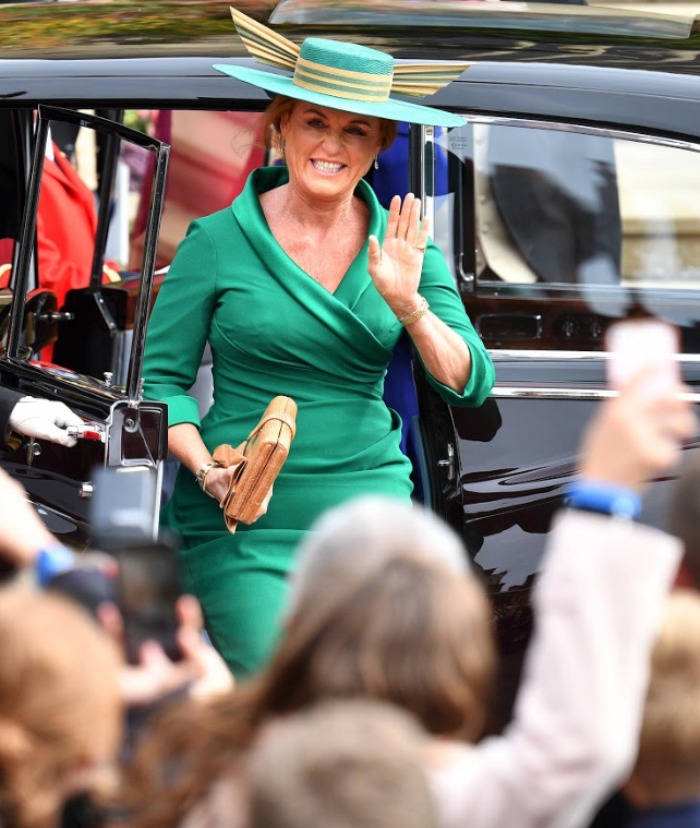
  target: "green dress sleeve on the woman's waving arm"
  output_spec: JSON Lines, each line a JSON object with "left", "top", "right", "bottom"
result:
{"left": 416, "top": 242, "right": 496, "bottom": 406}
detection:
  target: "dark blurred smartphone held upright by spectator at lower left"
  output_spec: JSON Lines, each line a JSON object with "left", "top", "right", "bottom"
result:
{"left": 116, "top": 542, "right": 181, "bottom": 664}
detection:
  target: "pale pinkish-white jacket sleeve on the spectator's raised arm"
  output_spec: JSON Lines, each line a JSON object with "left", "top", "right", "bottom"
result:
{"left": 431, "top": 510, "right": 681, "bottom": 828}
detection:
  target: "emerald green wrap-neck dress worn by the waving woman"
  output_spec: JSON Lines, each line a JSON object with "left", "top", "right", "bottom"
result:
{"left": 144, "top": 167, "right": 494, "bottom": 677}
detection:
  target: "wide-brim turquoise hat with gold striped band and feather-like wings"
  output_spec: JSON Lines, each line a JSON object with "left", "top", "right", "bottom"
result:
{"left": 214, "top": 9, "right": 470, "bottom": 127}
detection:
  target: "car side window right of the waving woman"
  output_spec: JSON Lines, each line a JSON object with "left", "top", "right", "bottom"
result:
{"left": 433, "top": 119, "right": 700, "bottom": 350}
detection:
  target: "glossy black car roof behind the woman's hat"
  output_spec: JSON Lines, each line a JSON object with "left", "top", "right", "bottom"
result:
{"left": 0, "top": 0, "right": 700, "bottom": 140}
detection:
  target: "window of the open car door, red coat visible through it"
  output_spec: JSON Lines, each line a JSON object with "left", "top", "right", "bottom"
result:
{"left": 3, "top": 106, "right": 168, "bottom": 399}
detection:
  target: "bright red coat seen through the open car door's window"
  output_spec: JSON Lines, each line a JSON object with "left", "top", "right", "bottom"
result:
{"left": 37, "top": 144, "right": 97, "bottom": 308}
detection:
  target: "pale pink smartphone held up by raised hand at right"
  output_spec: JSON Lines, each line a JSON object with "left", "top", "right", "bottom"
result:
{"left": 605, "top": 319, "right": 681, "bottom": 391}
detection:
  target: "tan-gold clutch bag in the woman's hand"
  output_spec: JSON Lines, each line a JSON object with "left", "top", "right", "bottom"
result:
{"left": 213, "top": 397, "right": 297, "bottom": 532}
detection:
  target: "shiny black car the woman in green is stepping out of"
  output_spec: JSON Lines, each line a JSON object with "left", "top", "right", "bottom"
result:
{"left": 0, "top": 0, "right": 700, "bottom": 720}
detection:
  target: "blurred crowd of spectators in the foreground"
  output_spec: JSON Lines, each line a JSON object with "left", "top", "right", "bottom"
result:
{"left": 0, "top": 364, "right": 700, "bottom": 828}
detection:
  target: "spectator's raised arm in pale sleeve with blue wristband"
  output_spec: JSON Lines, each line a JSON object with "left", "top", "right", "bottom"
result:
{"left": 435, "top": 377, "right": 696, "bottom": 828}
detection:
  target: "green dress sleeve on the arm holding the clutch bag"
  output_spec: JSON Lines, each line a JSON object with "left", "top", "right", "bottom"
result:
{"left": 143, "top": 221, "right": 217, "bottom": 427}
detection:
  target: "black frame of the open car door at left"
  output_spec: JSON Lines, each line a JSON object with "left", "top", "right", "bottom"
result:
{"left": 0, "top": 104, "right": 170, "bottom": 548}
